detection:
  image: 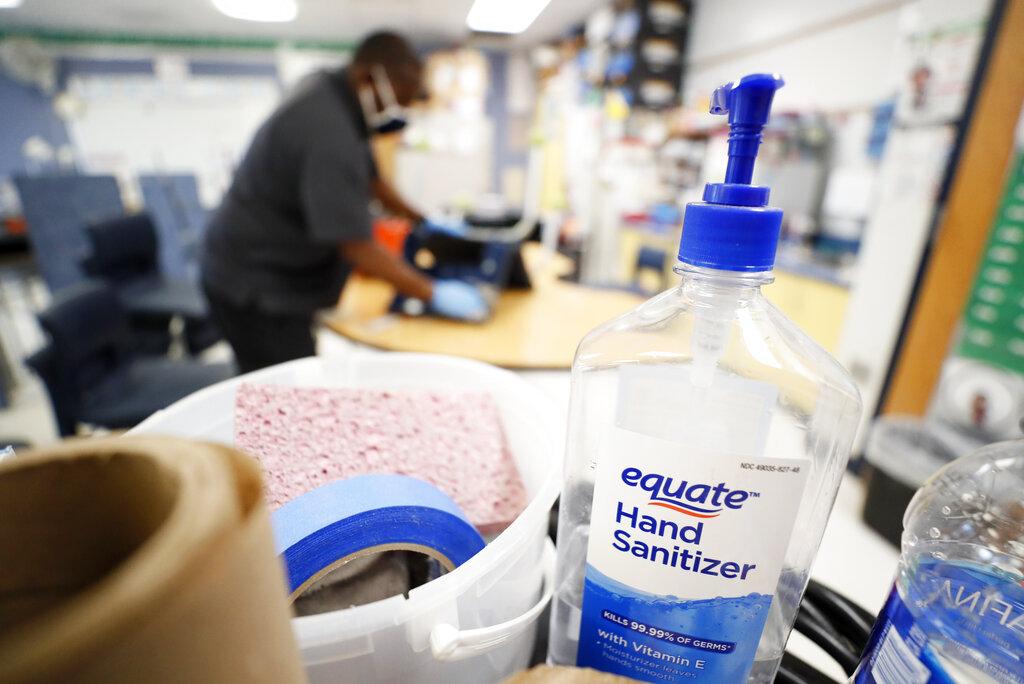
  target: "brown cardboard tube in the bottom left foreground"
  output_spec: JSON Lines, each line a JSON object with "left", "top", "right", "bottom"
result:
{"left": 0, "top": 437, "right": 306, "bottom": 684}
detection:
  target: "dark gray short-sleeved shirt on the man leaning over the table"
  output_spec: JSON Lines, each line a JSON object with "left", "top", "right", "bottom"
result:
{"left": 203, "top": 71, "right": 377, "bottom": 313}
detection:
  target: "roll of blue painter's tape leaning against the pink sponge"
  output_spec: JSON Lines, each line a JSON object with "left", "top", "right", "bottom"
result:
{"left": 270, "top": 475, "right": 483, "bottom": 600}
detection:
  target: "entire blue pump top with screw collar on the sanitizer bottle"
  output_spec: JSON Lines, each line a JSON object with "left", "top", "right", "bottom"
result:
{"left": 679, "top": 74, "right": 784, "bottom": 271}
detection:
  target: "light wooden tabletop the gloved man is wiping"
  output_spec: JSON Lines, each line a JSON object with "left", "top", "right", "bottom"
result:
{"left": 324, "top": 244, "right": 643, "bottom": 369}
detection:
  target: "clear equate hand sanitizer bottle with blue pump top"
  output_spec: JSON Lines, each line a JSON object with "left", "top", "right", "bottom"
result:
{"left": 548, "top": 74, "right": 861, "bottom": 682}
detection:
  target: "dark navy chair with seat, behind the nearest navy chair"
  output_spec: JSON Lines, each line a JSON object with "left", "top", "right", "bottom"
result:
{"left": 83, "top": 214, "right": 220, "bottom": 353}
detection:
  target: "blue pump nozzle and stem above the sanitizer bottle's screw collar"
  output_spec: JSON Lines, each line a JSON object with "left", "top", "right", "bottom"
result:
{"left": 711, "top": 74, "right": 784, "bottom": 185}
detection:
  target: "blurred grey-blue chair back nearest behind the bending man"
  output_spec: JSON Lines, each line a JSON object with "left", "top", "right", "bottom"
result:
{"left": 138, "top": 174, "right": 207, "bottom": 279}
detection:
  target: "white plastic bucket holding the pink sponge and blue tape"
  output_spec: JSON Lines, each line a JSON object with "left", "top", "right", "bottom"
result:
{"left": 133, "top": 352, "right": 563, "bottom": 684}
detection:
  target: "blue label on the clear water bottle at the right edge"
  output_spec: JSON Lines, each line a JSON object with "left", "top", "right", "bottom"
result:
{"left": 854, "top": 561, "right": 1024, "bottom": 684}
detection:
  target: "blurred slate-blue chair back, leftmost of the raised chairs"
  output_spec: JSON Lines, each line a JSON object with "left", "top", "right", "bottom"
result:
{"left": 13, "top": 175, "right": 124, "bottom": 292}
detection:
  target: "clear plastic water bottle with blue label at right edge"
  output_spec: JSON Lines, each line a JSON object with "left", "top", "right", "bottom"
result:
{"left": 854, "top": 440, "right": 1024, "bottom": 684}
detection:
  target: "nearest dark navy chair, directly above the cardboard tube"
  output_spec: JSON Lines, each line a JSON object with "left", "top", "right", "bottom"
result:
{"left": 27, "top": 281, "right": 233, "bottom": 436}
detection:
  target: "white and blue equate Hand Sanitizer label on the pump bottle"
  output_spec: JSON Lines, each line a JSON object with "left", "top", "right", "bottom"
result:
{"left": 577, "top": 371, "right": 809, "bottom": 682}
